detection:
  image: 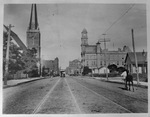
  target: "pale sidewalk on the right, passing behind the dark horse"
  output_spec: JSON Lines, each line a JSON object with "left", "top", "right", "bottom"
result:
{"left": 92, "top": 77, "right": 148, "bottom": 88}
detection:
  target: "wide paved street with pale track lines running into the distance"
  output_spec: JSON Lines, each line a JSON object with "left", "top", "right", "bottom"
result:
{"left": 3, "top": 77, "right": 148, "bottom": 114}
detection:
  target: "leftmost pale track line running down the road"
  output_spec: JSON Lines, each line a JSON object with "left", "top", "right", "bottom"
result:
{"left": 32, "top": 79, "right": 60, "bottom": 114}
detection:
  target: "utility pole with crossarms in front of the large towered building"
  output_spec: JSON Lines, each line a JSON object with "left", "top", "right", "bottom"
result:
{"left": 99, "top": 34, "right": 110, "bottom": 80}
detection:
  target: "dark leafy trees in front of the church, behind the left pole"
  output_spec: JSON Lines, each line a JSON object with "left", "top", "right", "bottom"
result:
{"left": 3, "top": 32, "right": 38, "bottom": 79}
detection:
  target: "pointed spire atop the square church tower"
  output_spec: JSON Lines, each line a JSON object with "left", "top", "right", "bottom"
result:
{"left": 29, "top": 4, "right": 38, "bottom": 30}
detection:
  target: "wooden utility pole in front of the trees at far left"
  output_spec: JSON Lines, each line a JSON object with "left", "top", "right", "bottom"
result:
{"left": 4, "top": 24, "right": 14, "bottom": 85}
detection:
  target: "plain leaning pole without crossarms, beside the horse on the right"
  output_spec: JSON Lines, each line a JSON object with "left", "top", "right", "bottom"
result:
{"left": 131, "top": 29, "right": 139, "bottom": 85}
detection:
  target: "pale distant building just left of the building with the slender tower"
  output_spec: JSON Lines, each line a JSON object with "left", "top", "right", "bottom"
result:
{"left": 66, "top": 59, "right": 81, "bottom": 75}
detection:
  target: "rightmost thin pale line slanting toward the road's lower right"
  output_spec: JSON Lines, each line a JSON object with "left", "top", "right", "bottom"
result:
{"left": 74, "top": 82, "right": 133, "bottom": 113}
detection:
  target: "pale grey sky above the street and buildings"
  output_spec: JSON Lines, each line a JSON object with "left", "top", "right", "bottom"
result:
{"left": 4, "top": 3, "right": 147, "bottom": 68}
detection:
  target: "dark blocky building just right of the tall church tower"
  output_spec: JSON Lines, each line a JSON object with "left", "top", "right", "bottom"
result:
{"left": 42, "top": 57, "right": 59, "bottom": 75}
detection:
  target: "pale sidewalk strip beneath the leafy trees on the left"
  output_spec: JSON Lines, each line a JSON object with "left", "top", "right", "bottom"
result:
{"left": 3, "top": 77, "right": 44, "bottom": 88}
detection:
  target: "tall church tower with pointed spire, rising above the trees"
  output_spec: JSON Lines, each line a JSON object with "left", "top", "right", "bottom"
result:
{"left": 27, "top": 4, "right": 41, "bottom": 72}
